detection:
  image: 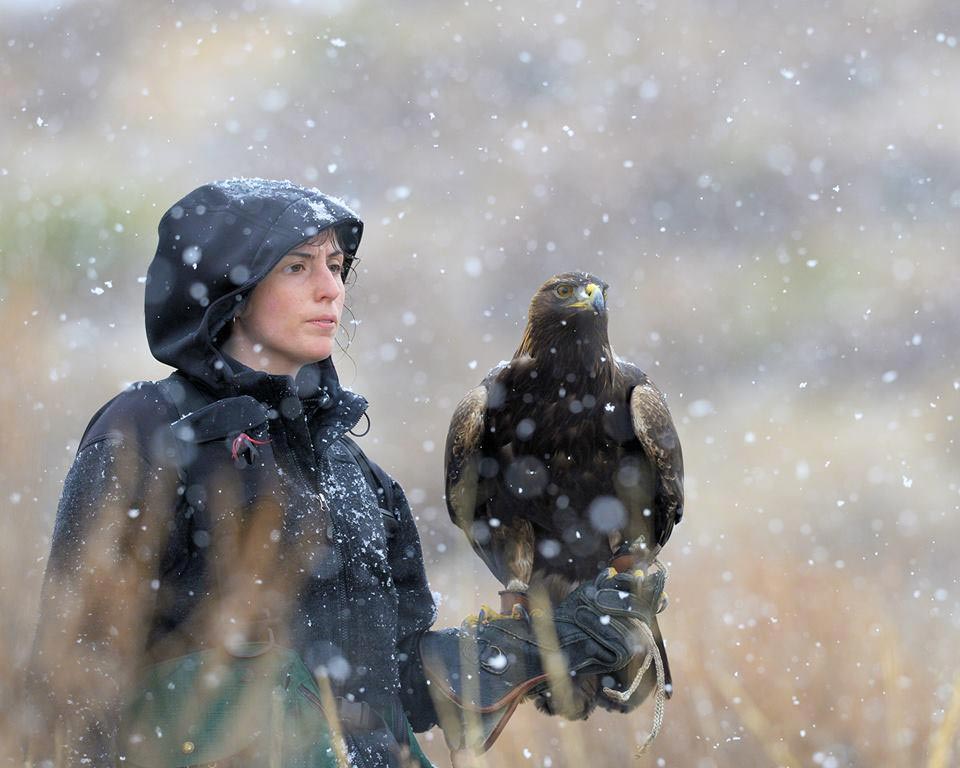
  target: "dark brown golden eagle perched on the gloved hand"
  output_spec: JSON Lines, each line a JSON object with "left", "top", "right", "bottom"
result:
{"left": 446, "top": 272, "right": 683, "bottom": 712}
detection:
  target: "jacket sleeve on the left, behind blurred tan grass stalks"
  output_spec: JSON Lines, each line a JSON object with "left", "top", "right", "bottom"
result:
{"left": 26, "top": 400, "right": 177, "bottom": 765}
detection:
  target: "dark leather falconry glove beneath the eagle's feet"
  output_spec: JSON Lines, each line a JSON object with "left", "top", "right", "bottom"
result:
{"left": 420, "top": 569, "right": 666, "bottom": 753}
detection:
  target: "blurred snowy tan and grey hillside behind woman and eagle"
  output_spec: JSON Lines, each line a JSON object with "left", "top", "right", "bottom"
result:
{"left": 0, "top": 0, "right": 960, "bottom": 768}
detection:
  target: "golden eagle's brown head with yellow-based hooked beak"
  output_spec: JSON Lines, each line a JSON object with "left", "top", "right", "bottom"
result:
{"left": 517, "top": 272, "right": 609, "bottom": 357}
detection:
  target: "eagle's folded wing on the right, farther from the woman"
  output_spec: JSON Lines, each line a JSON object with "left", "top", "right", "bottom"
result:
{"left": 620, "top": 362, "right": 683, "bottom": 551}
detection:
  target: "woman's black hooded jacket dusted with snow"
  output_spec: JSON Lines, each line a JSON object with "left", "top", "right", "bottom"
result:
{"left": 30, "top": 179, "right": 435, "bottom": 766}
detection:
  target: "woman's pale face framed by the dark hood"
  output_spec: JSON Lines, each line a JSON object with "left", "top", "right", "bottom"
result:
{"left": 224, "top": 232, "right": 344, "bottom": 376}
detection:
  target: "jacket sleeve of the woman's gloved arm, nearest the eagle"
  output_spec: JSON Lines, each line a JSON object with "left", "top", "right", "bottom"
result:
{"left": 390, "top": 481, "right": 437, "bottom": 732}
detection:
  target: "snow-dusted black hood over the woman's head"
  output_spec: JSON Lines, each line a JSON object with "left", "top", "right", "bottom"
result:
{"left": 145, "top": 179, "right": 363, "bottom": 386}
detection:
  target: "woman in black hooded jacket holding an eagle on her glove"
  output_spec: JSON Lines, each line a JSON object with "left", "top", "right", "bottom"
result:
{"left": 30, "top": 179, "right": 662, "bottom": 766}
